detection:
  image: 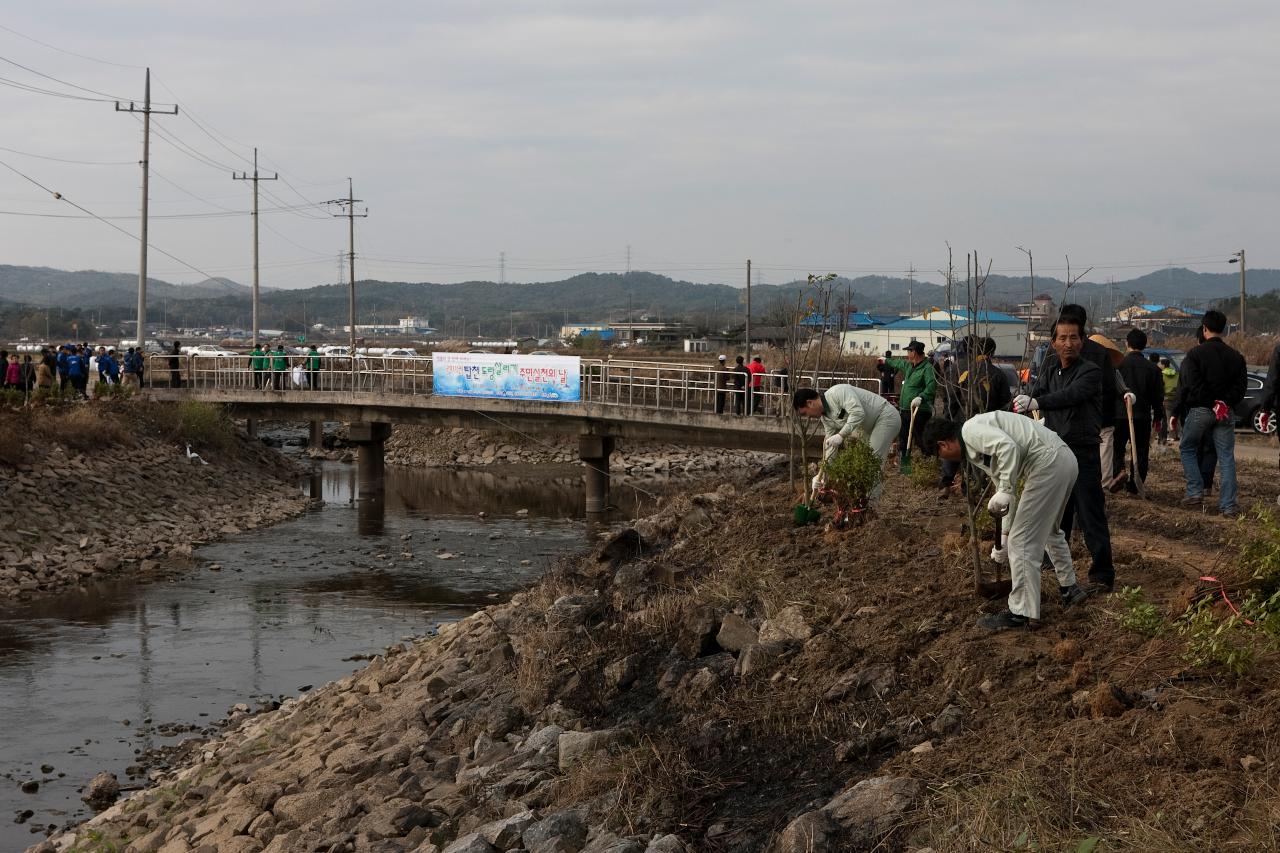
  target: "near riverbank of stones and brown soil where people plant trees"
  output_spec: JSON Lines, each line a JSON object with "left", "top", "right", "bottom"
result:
{"left": 32, "top": 456, "right": 1280, "bottom": 853}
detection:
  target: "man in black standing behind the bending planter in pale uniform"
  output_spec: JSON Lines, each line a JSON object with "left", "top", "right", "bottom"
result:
{"left": 1014, "top": 315, "right": 1116, "bottom": 592}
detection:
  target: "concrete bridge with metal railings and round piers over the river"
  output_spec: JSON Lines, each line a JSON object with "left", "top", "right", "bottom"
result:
{"left": 143, "top": 356, "right": 876, "bottom": 512}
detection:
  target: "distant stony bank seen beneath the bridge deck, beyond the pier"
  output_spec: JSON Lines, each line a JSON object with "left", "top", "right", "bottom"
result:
{"left": 376, "top": 425, "right": 782, "bottom": 476}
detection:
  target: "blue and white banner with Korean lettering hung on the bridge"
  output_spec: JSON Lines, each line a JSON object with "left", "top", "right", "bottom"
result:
{"left": 431, "top": 352, "right": 582, "bottom": 402}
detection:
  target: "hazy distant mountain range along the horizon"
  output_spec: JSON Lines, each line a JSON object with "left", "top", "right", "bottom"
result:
{"left": 0, "top": 265, "right": 1280, "bottom": 337}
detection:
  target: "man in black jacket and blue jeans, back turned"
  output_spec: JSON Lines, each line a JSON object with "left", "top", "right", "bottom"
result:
{"left": 1178, "top": 311, "right": 1248, "bottom": 519}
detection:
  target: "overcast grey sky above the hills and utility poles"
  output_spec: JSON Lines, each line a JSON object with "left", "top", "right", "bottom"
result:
{"left": 0, "top": 0, "right": 1280, "bottom": 287}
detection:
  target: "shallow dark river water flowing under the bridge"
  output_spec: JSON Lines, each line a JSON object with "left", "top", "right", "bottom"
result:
{"left": 0, "top": 464, "right": 640, "bottom": 852}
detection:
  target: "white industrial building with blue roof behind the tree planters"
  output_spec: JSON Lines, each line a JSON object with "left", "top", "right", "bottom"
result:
{"left": 841, "top": 309, "right": 1027, "bottom": 359}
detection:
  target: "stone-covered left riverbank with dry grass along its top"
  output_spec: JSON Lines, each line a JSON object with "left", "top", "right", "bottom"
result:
{"left": 0, "top": 400, "right": 307, "bottom": 603}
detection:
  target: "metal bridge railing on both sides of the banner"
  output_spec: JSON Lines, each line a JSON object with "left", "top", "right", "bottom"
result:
{"left": 143, "top": 353, "right": 877, "bottom": 418}
